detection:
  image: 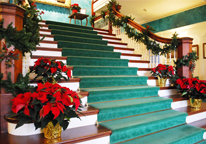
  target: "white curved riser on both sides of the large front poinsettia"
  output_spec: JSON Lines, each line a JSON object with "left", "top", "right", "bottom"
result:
{"left": 7, "top": 115, "right": 97, "bottom": 136}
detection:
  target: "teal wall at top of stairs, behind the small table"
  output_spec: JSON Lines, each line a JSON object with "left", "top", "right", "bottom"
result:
{"left": 36, "top": 0, "right": 92, "bottom": 26}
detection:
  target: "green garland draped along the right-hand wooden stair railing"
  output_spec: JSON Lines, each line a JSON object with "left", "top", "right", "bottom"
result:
{"left": 102, "top": 0, "right": 179, "bottom": 55}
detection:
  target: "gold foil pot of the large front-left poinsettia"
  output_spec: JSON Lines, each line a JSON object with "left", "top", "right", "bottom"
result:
{"left": 44, "top": 121, "right": 62, "bottom": 139}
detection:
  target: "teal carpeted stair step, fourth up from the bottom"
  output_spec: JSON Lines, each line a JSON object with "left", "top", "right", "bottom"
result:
{"left": 81, "top": 86, "right": 159, "bottom": 104}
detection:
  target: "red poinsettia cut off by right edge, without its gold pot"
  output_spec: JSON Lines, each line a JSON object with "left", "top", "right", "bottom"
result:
{"left": 175, "top": 78, "right": 206, "bottom": 99}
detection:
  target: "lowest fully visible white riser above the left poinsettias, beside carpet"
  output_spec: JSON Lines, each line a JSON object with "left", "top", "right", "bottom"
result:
{"left": 32, "top": 50, "right": 62, "bottom": 56}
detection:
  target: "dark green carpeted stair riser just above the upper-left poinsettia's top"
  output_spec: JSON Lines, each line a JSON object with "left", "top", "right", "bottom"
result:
{"left": 62, "top": 48, "right": 121, "bottom": 58}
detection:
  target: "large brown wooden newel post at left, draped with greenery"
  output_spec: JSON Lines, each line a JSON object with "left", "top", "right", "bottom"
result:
{"left": 0, "top": 3, "right": 25, "bottom": 133}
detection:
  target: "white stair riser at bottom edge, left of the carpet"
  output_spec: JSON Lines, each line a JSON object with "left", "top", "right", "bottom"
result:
{"left": 76, "top": 136, "right": 110, "bottom": 144}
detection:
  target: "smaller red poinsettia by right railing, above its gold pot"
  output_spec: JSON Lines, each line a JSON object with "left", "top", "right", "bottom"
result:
{"left": 151, "top": 64, "right": 174, "bottom": 78}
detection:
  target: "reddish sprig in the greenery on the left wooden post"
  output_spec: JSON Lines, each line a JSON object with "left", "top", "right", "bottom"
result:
{"left": 0, "top": 43, "right": 19, "bottom": 68}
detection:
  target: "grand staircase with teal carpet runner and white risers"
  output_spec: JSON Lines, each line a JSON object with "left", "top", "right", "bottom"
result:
{"left": 14, "top": 21, "right": 206, "bottom": 144}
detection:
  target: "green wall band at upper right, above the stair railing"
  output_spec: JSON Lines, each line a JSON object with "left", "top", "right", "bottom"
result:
{"left": 143, "top": 5, "right": 206, "bottom": 32}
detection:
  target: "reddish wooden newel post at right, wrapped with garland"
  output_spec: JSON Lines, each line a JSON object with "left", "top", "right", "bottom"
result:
{"left": 177, "top": 37, "right": 193, "bottom": 78}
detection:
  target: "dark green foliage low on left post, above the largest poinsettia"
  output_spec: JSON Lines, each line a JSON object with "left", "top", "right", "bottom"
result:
{"left": 0, "top": 72, "right": 36, "bottom": 97}
